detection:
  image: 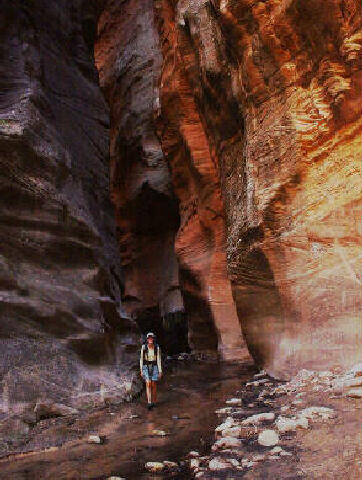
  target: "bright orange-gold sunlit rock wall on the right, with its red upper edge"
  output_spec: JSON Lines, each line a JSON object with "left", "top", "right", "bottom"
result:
{"left": 155, "top": 0, "right": 362, "bottom": 375}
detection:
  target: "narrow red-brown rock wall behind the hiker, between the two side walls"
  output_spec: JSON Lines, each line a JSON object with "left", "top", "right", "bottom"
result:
{"left": 95, "top": 0, "right": 247, "bottom": 358}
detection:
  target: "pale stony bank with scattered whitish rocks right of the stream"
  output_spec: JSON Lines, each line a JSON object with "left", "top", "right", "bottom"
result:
{"left": 188, "top": 365, "right": 362, "bottom": 480}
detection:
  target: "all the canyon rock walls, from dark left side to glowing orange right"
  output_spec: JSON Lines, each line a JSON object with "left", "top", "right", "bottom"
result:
{"left": 0, "top": 0, "right": 362, "bottom": 478}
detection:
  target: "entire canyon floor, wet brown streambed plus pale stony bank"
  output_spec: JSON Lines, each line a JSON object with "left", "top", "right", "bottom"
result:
{"left": 0, "top": 359, "right": 362, "bottom": 480}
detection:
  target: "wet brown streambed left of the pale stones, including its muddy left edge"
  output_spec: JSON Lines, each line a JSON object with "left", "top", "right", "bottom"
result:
{"left": 0, "top": 355, "right": 256, "bottom": 480}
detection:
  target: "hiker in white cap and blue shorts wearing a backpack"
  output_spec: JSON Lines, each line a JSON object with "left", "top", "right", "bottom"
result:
{"left": 140, "top": 332, "right": 162, "bottom": 410}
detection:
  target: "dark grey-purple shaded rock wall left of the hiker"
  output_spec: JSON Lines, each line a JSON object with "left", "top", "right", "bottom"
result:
{"left": 0, "top": 0, "right": 138, "bottom": 412}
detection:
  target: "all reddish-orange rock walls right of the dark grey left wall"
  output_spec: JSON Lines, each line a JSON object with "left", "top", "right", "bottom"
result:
{"left": 96, "top": 0, "right": 361, "bottom": 375}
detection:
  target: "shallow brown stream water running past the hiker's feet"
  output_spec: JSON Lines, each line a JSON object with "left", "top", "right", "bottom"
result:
{"left": 0, "top": 361, "right": 255, "bottom": 480}
